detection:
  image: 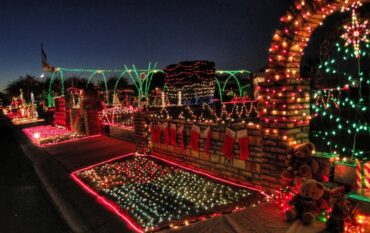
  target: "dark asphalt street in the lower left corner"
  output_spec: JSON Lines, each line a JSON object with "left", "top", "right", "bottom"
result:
{"left": 0, "top": 116, "right": 70, "bottom": 233}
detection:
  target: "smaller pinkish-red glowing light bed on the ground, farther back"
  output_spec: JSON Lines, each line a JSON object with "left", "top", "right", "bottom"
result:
{"left": 23, "top": 125, "right": 85, "bottom": 145}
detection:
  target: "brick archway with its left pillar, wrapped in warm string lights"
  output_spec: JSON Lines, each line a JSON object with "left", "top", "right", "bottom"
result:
{"left": 259, "top": 0, "right": 370, "bottom": 178}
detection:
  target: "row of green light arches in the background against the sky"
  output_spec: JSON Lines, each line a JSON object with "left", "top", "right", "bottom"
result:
{"left": 44, "top": 63, "right": 250, "bottom": 107}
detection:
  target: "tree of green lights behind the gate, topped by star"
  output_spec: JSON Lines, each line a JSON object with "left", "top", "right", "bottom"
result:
{"left": 311, "top": 5, "right": 370, "bottom": 160}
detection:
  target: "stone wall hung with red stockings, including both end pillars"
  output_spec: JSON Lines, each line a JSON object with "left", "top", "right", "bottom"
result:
{"left": 135, "top": 80, "right": 310, "bottom": 190}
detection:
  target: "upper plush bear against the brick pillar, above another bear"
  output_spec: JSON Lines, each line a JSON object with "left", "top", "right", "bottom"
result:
{"left": 281, "top": 142, "right": 319, "bottom": 185}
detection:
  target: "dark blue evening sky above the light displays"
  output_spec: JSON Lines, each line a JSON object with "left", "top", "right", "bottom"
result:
{"left": 0, "top": 0, "right": 292, "bottom": 90}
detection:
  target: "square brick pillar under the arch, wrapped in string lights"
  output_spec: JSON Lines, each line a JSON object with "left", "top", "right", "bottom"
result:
{"left": 259, "top": 80, "right": 310, "bottom": 188}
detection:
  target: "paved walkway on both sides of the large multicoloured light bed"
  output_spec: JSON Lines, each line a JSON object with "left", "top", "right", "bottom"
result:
{"left": 12, "top": 121, "right": 298, "bottom": 233}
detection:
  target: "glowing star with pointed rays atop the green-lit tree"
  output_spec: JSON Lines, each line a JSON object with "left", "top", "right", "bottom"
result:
{"left": 341, "top": 10, "right": 370, "bottom": 58}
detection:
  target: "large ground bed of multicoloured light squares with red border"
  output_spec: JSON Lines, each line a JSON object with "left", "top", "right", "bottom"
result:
{"left": 72, "top": 155, "right": 268, "bottom": 232}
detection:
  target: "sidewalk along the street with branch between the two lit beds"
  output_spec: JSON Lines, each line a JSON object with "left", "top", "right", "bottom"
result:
{"left": 10, "top": 121, "right": 135, "bottom": 233}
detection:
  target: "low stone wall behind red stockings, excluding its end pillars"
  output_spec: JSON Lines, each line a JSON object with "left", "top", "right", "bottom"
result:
{"left": 148, "top": 118, "right": 279, "bottom": 190}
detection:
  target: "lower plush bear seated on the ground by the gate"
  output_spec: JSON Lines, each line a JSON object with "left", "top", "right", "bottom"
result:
{"left": 285, "top": 179, "right": 329, "bottom": 225}
